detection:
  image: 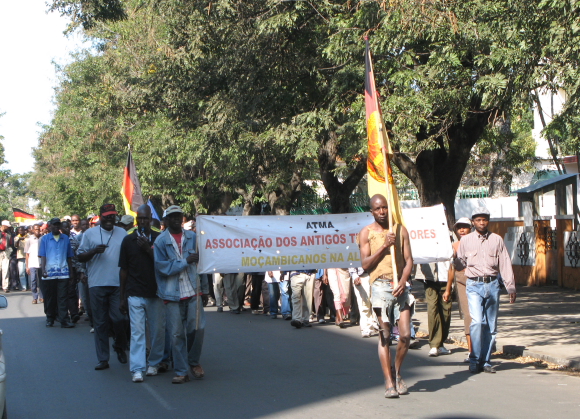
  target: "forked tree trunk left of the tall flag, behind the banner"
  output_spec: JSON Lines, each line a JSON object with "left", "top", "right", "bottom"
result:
{"left": 318, "top": 132, "right": 367, "bottom": 214}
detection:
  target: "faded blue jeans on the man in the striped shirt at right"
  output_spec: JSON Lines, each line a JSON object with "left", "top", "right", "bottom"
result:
{"left": 467, "top": 279, "right": 500, "bottom": 368}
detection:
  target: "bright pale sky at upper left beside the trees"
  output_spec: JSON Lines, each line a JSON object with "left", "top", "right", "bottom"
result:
{"left": 0, "top": 0, "right": 82, "bottom": 173}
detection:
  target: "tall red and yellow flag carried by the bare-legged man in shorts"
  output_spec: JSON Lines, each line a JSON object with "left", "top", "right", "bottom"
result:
{"left": 365, "top": 40, "right": 404, "bottom": 225}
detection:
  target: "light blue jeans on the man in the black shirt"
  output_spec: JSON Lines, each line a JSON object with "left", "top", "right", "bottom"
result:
{"left": 127, "top": 297, "right": 165, "bottom": 372}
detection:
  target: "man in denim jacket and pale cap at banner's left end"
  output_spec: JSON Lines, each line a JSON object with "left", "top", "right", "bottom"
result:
{"left": 153, "top": 205, "right": 209, "bottom": 384}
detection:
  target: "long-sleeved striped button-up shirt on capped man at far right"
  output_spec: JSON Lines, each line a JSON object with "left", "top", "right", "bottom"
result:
{"left": 455, "top": 231, "right": 516, "bottom": 294}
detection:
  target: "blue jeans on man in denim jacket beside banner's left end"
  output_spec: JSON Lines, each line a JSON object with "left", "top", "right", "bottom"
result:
{"left": 165, "top": 297, "right": 205, "bottom": 376}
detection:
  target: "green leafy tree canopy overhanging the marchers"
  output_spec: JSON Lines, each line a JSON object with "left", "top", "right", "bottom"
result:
{"left": 33, "top": 0, "right": 579, "bottom": 219}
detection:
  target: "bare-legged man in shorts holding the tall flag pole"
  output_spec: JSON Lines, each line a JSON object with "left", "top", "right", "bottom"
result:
{"left": 359, "top": 194, "right": 413, "bottom": 398}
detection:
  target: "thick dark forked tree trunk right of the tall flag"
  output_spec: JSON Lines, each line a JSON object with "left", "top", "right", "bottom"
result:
{"left": 393, "top": 112, "right": 489, "bottom": 228}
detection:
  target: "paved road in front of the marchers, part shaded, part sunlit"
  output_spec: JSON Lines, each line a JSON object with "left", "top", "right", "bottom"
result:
{"left": 0, "top": 293, "right": 580, "bottom": 419}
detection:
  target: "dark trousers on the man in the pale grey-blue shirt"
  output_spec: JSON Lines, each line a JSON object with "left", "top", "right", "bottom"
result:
{"left": 89, "top": 287, "right": 127, "bottom": 362}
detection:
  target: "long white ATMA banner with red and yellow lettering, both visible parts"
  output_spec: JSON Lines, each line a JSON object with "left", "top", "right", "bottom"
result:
{"left": 196, "top": 205, "right": 453, "bottom": 274}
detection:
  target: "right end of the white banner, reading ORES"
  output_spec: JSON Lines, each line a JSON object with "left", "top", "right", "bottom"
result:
{"left": 403, "top": 205, "right": 453, "bottom": 264}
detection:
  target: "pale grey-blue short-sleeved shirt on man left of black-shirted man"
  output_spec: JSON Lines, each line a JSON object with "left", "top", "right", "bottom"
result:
{"left": 77, "top": 226, "right": 127, "bottom": 288}
